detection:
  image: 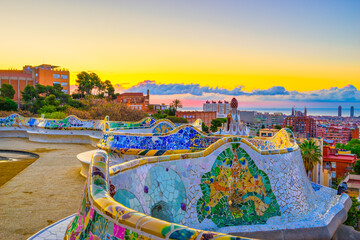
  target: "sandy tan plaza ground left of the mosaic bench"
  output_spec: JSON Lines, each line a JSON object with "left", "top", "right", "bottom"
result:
{"left": 0, "top": 138, "right": 95, "bottom": 240}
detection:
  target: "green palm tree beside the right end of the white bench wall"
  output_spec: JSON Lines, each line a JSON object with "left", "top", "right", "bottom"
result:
{"left": 300, "top": 139, "right": 321, "bottom": 176}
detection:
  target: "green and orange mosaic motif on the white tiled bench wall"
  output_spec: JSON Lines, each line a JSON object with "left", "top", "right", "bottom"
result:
{"left": 197, "top": 144, "right": 281, "bottom": 227}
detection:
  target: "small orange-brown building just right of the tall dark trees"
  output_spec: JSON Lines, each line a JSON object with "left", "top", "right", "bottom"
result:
{"left": 116, "top": 90, "right": 150, "bottom": 111}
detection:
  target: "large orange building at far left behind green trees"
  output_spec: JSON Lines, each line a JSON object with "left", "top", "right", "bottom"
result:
{"left": 0, "top": 64, "right": 70, "bottom": 103}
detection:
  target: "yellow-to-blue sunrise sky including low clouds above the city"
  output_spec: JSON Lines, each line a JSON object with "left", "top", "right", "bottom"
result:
{"left": 0, "top": 0, "right": 360, "bottom": 106}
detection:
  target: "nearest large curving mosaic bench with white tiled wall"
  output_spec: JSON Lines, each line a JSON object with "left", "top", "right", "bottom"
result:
{"left": 65, "top": 130, "right": 351, "bottom": 240}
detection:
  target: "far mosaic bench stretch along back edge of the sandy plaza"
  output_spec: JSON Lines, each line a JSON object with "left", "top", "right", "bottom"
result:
{"left": 0, "top": 114, "right": 191, "bottom": 146}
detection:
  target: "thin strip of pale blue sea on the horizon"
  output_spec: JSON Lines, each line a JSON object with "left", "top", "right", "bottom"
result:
{"left": 181, "top": 107, "right": 360, "bottom": 117}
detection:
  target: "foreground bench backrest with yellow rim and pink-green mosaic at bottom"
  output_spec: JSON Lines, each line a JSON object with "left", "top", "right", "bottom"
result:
{"left": 65, "top": 152, "right": 250, "bottom": 240}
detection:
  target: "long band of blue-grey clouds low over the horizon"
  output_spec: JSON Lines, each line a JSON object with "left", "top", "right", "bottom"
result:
{"left": 71, "top": 80, "right": 360, "bottom": 103}
